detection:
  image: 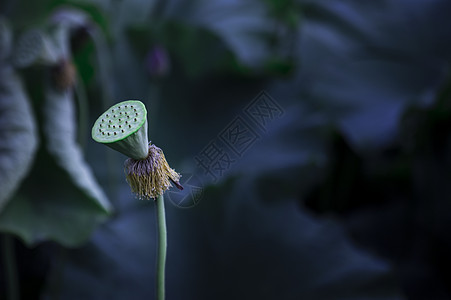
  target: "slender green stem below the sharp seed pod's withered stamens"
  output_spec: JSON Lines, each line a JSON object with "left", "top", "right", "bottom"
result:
{"left": 156, "top": 195, "right": 168, "bottom": 300}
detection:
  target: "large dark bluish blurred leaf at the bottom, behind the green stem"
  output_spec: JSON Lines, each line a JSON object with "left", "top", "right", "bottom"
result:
{"left": 41, "top": 185, "right": 402, "bottom": 300}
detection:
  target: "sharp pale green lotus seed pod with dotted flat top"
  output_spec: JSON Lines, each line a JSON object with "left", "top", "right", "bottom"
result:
{"left": 92, "top": 100, "right": 149, "bottom": 160}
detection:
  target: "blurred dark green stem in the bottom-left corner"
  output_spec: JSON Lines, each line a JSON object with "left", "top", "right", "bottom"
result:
{"left": 2, "top": 234, "right": 20, "bottom": 300}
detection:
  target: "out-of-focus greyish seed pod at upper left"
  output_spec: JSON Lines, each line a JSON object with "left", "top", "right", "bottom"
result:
{"left": 13, "top": 29, "right": 58, "bottom": 68}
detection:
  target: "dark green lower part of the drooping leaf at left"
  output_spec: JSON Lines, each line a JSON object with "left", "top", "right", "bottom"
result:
{"left": 0, "top": 148, "right": 111, "bottom": 247}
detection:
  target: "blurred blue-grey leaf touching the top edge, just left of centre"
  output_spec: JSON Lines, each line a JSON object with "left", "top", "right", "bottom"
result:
{"left": 163, "top": 0, "right": 273, "bottom": 67}
